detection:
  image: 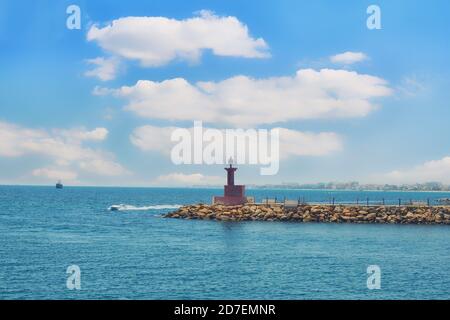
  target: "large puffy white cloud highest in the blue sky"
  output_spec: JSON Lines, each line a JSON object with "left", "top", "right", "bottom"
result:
{"left": 87, "top": 10, "right": 269, "bottom": 67}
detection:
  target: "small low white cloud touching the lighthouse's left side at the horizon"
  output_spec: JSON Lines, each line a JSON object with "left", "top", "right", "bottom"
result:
{"left": 155, "top": 173, "right": 225, "bottom": 186}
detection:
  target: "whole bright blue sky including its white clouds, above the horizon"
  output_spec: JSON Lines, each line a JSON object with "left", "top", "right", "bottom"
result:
{"left": 0, "top": 0, "right": 450, "bottom": 186}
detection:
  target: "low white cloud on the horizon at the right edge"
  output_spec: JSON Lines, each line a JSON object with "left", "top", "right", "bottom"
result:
{"left": 383, "top": 156, "right": 450, "bottom": 184}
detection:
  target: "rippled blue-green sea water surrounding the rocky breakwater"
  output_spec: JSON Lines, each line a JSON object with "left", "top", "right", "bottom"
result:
{"left": 0, "top": 186, "right": 450, "bottom": 299}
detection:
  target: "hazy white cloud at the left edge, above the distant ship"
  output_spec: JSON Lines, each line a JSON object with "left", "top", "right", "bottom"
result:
{"left": 0, "top": 122, "right": 128, "bottom": 180}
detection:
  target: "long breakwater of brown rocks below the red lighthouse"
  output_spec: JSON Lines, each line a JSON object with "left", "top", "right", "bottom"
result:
{"left": 164, "top": 204, "right": 450, "bottom": 225}
